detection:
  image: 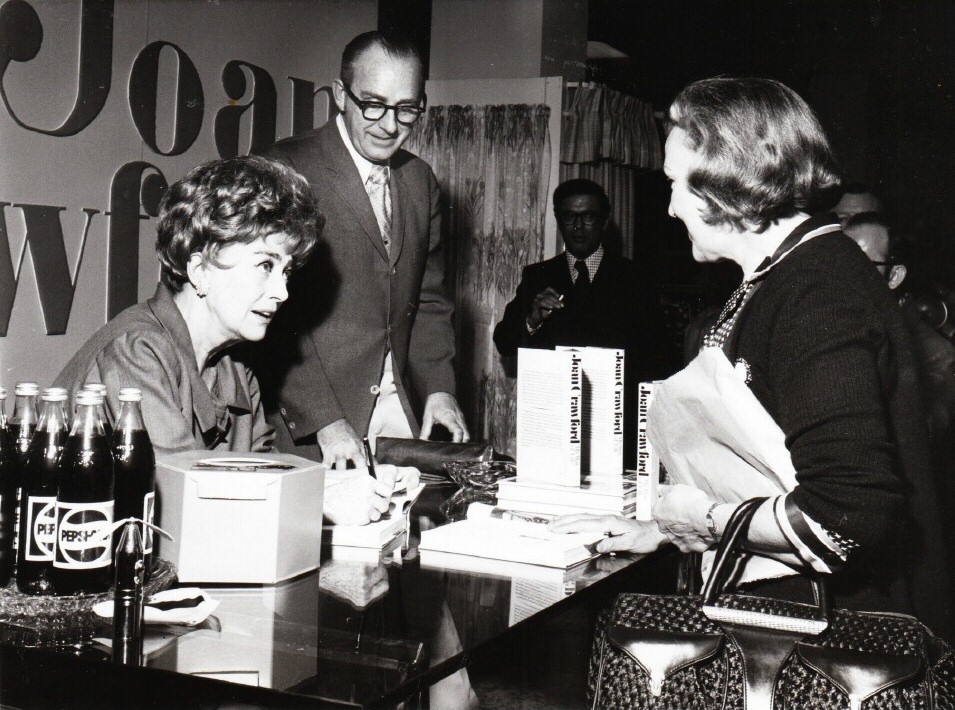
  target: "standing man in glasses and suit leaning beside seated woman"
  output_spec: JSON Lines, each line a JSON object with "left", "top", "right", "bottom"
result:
{"left": 260, "top": 32, "right": 469, "bottom": 468}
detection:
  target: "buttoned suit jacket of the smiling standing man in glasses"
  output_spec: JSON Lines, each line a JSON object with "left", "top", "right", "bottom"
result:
{"left": 259, "top": 120, "right": 455, "bottom": 458}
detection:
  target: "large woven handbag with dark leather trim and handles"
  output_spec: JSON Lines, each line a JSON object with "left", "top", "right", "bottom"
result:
{"left": 588, "top": 498, "right": 955, "bottom": 710}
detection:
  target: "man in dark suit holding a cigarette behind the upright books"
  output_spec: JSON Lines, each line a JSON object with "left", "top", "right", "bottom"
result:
{"left": 494, "top": 179, "right": 666, "bottom": 465}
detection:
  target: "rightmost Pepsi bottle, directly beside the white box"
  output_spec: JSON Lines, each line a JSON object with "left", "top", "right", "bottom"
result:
{"left": 113, "top": 387, "right": 156, "bottom": 579}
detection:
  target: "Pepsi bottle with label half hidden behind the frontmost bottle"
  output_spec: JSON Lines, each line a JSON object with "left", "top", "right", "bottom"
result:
{"left": 17, "top": 388, "right": 68, "bottom": 594}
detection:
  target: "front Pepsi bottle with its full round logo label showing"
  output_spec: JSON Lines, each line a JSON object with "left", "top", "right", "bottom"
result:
{"left": 53, "top": 392, "right": 113, "bottom": 594}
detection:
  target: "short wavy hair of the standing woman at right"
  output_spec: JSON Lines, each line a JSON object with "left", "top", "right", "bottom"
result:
{"left": 669, "top": 78, "right": 841, "bottom": 232}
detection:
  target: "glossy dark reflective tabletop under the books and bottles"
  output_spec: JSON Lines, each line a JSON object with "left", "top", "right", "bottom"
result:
{"left": 0, "top": 484, "right": 668, "bottom": 708}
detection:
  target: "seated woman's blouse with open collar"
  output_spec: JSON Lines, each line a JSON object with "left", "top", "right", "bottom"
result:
{"left": 56, "top": 284, "right": 274, "bottom": 455}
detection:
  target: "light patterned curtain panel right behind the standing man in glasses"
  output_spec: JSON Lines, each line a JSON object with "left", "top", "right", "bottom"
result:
{"left": 408, "top": 105, "right": 550, "bottom": 455}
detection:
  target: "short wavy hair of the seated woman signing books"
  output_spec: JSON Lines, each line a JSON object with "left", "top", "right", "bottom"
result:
{"left": 156, "top": 155, "right": 324, "bottom": 292}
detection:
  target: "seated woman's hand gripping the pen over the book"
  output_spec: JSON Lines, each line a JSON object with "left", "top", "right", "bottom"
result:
{"left": 324, "top": 465, "right": 397, "bottom": 525}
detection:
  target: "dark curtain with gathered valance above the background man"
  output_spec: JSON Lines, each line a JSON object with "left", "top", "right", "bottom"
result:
{"left": 560, "top": 84, "right": 663, "bottom": 256}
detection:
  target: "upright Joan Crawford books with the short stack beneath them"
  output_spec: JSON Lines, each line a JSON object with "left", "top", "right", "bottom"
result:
{"left": 512, "top": 348, "right": 660, "bottom": 520}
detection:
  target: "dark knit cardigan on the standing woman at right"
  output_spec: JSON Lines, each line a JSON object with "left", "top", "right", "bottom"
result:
{"left": 728, "top": 218, "right": 952, "bottom": 638}
